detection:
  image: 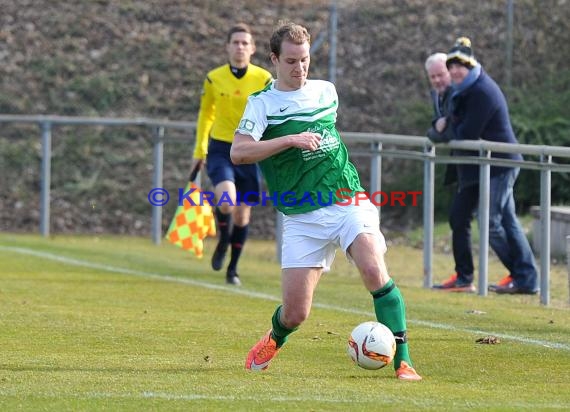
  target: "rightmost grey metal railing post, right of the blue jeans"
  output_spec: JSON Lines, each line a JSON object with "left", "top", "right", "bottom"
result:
{"left": 540, "top": 155, "right": 552, "bottom": 306}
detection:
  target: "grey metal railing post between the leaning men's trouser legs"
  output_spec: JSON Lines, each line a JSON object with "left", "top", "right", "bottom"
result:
{"left": 478, "top": 149, "right": 491, "bottom": 296}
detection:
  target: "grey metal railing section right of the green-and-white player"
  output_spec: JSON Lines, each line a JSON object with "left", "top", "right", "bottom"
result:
{"left": 343, "top": 132, "right": 570, "bottom": 305}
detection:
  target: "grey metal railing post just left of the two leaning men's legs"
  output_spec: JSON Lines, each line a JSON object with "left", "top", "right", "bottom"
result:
{"left": 423, "top": 144, "right": 435, "bottom": 288}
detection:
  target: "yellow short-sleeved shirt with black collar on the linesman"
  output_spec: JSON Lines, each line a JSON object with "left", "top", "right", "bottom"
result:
{"left": 194, "top": 64, "right": 271, "bottom": 159}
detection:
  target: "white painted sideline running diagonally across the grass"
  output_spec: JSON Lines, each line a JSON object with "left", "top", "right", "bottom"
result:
{"left": 0, "top": 245, "right": 570, "bottom": 351}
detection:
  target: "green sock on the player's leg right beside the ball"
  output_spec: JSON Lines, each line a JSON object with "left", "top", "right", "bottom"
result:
{"left": 371, "top": 279, "right": 412, "bottom": 369}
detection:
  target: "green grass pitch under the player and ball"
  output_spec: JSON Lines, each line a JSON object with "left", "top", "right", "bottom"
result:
{"left": 0, "top": 233, "right": 570, "bottom": 411}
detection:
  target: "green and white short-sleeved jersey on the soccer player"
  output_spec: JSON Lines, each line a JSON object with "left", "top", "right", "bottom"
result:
{"left": 237, "top": 80, "right": 364, "bottom": 215}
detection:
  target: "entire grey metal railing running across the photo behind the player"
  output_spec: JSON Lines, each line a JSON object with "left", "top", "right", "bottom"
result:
{"left": 0, "top": 115, "right": 570, "bottom": 305}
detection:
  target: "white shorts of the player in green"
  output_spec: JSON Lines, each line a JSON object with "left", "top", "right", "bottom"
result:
{"left": 281, "top": 200, "right": 387, "bottom": 271}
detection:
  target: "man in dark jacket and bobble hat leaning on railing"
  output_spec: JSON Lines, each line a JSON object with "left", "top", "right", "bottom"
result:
{"left": 434, "top": 37, "right": 538, "bottom": 294}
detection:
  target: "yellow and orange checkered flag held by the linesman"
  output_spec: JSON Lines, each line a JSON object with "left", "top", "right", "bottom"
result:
{"left": 165, "top": 168, "right": 216, "bottom": 258}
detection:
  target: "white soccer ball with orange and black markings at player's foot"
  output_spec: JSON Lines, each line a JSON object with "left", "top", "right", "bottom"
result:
{"left": 346, "top": 322, "right": 396, "bottom": 370}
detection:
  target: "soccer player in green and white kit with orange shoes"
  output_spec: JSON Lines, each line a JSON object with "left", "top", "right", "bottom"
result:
{"left": 230, "top": 22, "right": 421, "bottom": 381}
